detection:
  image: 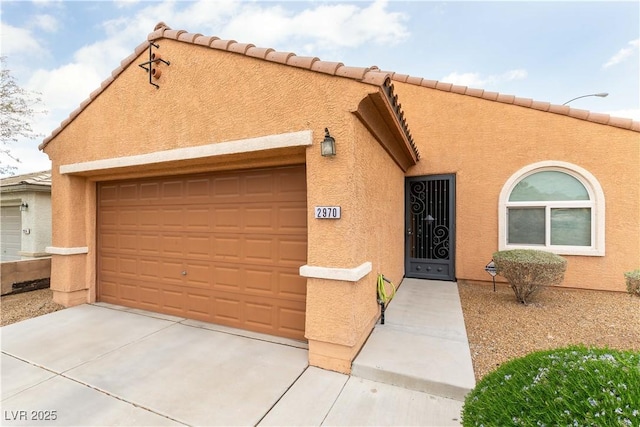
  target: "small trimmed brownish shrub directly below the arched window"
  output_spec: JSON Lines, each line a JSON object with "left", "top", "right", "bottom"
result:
{"left": 493, "top": 249, "right": 567, "bottom": 304}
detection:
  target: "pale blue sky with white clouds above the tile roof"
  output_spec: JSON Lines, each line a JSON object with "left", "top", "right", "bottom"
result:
{"left": 0, "top": 0, "right": 640, "bottom": 173}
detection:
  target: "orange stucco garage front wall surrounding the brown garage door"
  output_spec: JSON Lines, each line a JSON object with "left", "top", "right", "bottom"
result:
{"left": 45, "top": 40, "right": 403, "bottom": 371}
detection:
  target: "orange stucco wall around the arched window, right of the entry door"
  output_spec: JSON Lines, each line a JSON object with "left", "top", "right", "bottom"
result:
{"left": 394, "top": 82, "right": 640, "bottom": 291}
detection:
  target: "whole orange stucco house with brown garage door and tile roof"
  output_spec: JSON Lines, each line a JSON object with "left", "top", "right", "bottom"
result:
{"left": 40, "top": 23, "right": 640, "bottom": 372}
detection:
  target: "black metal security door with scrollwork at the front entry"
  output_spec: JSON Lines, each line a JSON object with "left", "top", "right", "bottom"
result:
{"left": 405, "top": 175, "right": 456, "bottom": 281}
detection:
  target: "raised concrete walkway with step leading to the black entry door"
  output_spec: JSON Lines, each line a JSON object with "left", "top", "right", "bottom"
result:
{"left": 351, "top": 279, "right": 475, "bottom": 401}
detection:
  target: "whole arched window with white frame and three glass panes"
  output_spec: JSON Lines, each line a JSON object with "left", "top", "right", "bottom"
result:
{"left": 498, "top": 161, "right": 605, "bottom": 256}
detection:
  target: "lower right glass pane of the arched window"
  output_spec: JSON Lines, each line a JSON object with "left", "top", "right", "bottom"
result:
{"left": 551, "top": 208, "right": 591, "bottom": 246}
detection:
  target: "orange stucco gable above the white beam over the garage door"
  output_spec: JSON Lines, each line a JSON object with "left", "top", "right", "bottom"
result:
{"left": 45, "top": 40, "right": 374, "bottom": 164}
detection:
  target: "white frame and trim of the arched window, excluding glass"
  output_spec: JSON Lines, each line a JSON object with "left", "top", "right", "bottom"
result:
{"left": 498, "top": 160, "right": 605, "bottom": 256}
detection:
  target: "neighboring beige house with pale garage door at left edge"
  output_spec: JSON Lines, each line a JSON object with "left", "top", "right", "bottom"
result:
{"left": 0, "top": 171, "right": 51, "bottom": 262}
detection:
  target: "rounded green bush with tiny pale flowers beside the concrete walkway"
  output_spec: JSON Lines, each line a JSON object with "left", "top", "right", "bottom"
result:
{"left": 462, "top": 346, "right": 640, "bottom": 426}
